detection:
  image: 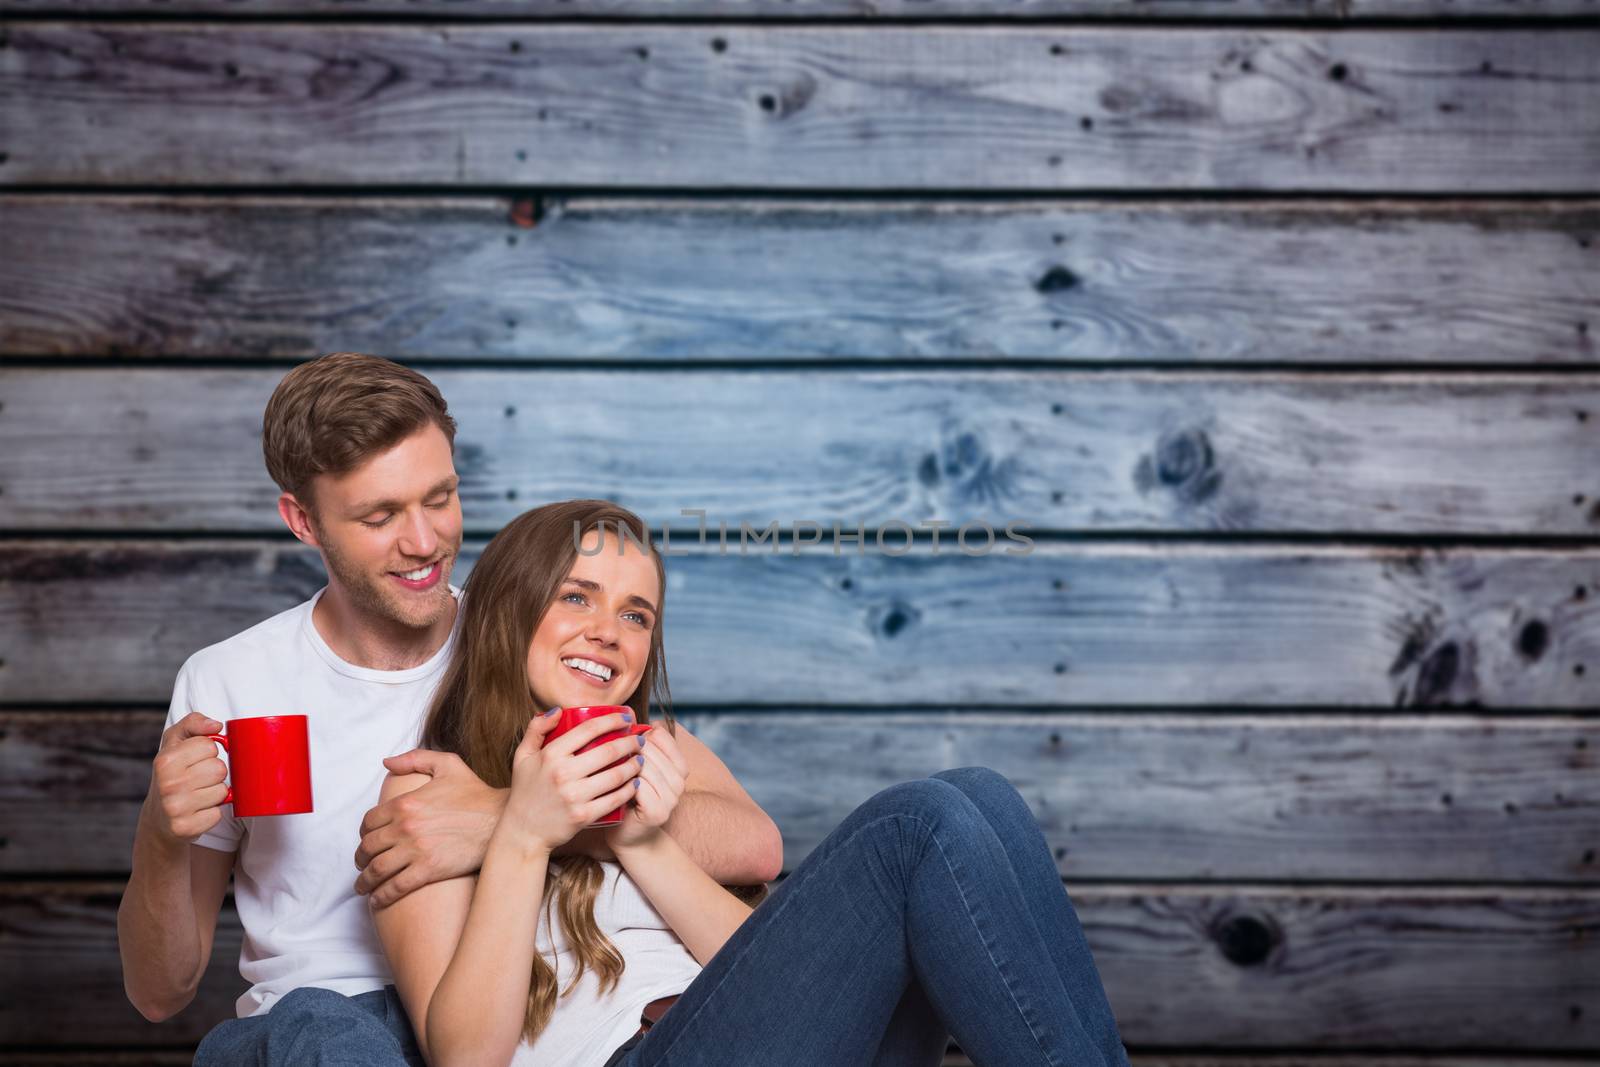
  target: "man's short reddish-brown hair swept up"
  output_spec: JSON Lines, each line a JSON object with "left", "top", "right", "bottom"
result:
{"left": 261, "top": 352, "right": 456, "bottom": 507}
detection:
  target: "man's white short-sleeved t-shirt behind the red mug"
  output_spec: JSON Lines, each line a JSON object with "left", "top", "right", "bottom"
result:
{"left": 166, "top": 589, "right": 461, "bottom": 1017}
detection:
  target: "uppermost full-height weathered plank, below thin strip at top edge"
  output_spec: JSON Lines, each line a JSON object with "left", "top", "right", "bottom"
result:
{"left": 0, "top": 22, "right": 1600, "bottom": 192}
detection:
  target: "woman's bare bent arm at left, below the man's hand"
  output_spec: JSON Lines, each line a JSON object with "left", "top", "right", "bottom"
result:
{"left": 373, "top": 774, "right": 549, "bottom": 1067}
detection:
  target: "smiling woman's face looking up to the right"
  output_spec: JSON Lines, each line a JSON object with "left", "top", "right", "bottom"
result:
{"left": 528, "top": 530, "right": 661, "bottom": 710}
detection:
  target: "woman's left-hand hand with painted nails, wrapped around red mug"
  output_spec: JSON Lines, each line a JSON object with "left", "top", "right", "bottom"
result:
{"left": 501, "top": 709, "right": 642, "bottom": 853}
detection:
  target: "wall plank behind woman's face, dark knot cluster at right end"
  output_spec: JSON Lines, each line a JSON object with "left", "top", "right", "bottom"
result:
{"left": 0, "top": 536, "right": 1600, "bottom": 709}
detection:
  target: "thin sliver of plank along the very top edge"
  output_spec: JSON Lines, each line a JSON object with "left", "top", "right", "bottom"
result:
{"left": 0, "top": 0, "right": 1600, "bottom": 22}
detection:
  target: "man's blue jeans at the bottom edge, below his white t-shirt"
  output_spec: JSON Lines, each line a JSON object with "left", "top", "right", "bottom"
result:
{"left": 195, "top": 985, "right": 426, "bottom": 1067}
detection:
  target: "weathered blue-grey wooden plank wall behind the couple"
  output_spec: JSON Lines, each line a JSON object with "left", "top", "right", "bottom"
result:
{"left": 0, "top": 0, "right": 1600, "bottom": 1067}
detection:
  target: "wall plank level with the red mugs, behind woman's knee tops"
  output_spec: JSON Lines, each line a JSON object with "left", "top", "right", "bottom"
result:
{"left": 0, "top": 709, "right": 1600, "bottom": 885}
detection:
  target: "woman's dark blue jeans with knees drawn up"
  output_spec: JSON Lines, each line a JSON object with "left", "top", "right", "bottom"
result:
{"left": 613, "top": 768, "right": 1128, "bottom": 1067}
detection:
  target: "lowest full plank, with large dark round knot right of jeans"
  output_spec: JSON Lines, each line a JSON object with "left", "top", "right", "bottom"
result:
{"left": 0, "top": 883, "right": 1600, "bottom": 1051}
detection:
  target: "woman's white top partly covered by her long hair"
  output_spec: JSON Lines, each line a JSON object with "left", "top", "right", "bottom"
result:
{"left": 510, "top": 862, "right": 701, "bottom": 1067}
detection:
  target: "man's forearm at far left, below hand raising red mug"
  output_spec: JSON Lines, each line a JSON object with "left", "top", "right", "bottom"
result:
{"left": 117, "top": 812, "right": 206, "bottom": 1022}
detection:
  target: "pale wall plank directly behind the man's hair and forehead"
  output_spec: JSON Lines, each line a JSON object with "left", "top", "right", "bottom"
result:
{"left": 0, "top": 368, "right": 1600, "bottom": 544}
